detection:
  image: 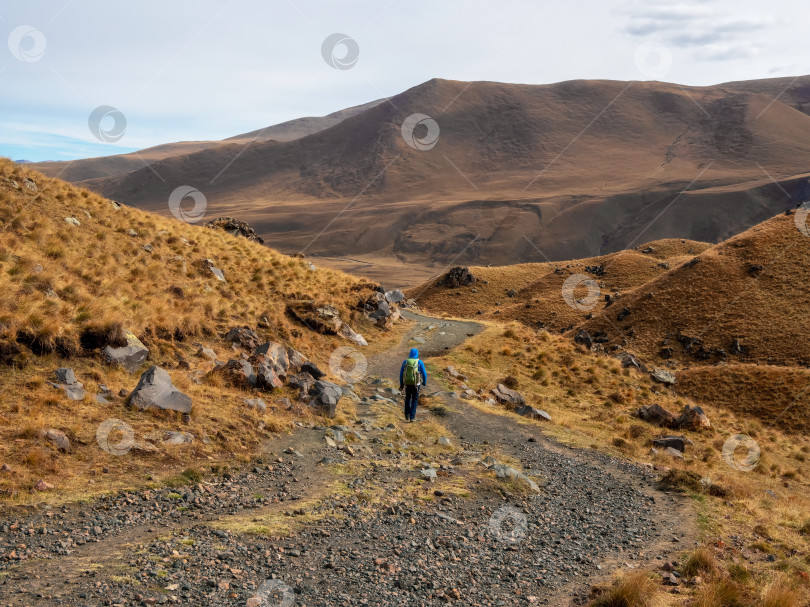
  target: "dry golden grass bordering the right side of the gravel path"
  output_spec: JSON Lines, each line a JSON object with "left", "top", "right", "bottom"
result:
{"left": 432, "top": 322, "right": 810, "bottom": 606}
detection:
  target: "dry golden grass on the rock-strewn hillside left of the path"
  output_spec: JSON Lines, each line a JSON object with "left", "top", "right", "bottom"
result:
{"left": 0, "top": 160, "right": 387, "bottom": 502}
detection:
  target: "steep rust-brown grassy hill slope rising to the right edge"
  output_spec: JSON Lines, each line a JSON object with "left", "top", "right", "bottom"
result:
{"left": 583, "top": 214, "right": 810, "bottom": 366}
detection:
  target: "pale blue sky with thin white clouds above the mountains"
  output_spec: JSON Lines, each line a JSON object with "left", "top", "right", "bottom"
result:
{"left": 0, "top": 0, "right": 810, "bottom": 161}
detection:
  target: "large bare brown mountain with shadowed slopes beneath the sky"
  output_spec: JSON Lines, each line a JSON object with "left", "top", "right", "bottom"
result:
{"left": 28, "top": 77, "right": 810, "bottom": 286}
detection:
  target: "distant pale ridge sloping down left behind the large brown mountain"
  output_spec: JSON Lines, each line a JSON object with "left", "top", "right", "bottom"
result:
{"left": 29, "top": 99, "right": 385, "bottom": 182}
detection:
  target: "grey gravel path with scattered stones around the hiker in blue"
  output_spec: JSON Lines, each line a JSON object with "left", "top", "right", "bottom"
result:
{"left": 0, "top": 314, "right": 692, "bottom": 607}
